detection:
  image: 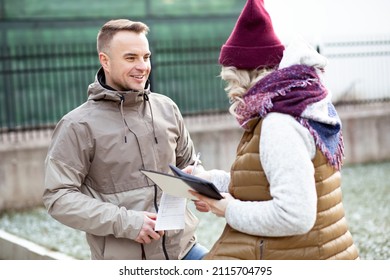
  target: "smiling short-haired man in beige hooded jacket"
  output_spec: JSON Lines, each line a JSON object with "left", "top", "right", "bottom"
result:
{"left": 43, "top": 19, "right": 207, "bottom": 259}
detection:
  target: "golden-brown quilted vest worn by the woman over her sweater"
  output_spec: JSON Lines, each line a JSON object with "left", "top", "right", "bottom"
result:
{"left": 205, "top": 120, "right": 359, "bottom": 260}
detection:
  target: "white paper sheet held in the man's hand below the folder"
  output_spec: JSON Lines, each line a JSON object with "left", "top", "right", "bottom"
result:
{"left": 154, "top": 192, "right": 187, "bottom": 231}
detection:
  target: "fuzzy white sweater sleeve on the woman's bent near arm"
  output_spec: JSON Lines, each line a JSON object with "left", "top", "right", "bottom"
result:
{"left": 225, "top": 113, "right": 317, "bottom": 236}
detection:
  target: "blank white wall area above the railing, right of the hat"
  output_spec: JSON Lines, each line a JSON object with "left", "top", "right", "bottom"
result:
{"left": 264, "top": 0, "right": 390, "bottom": 41}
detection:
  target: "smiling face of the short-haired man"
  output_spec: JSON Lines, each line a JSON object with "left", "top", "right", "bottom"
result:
{"left": 99, "top": 31, "right": 151, "bottom": 91}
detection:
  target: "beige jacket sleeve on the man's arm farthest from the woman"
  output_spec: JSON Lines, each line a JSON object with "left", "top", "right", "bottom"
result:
{"left": 43, "top": 119, "right": 143, "bottom": 239}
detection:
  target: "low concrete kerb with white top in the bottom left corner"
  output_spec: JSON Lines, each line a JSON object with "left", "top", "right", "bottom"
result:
{"left": 0, "top": 230, "right": 74, "bottom": 260}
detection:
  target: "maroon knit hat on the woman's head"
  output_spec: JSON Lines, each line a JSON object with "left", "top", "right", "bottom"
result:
{"left": 219, "top": 0, "right": 284, "bottom": 70}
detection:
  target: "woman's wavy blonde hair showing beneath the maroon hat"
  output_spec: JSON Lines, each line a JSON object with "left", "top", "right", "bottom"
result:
{"left": 220, "top": 66, "right": 272, "bottom": 117}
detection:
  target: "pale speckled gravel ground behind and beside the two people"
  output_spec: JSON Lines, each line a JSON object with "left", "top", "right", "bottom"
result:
{"left": 0, "top": 162, "right": 390, "bottom": 260}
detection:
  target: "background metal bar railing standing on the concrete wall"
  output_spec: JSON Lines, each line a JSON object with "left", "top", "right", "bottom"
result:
{"left": 0, "top": 39, "right": 390, "bottom": 141}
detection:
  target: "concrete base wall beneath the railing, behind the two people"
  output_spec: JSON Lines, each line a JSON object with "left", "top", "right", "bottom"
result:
{"left": 0, "top": 103, "right": 390, "bottom": 211}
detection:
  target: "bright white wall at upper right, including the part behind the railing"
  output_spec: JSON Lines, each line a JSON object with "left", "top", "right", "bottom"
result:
{"left": 265, "top": 0, "right": 390, "bottom": 102}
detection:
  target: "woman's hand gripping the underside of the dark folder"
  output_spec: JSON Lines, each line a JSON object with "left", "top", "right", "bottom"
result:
{"left": 189, "top": 190, "right": 234, "bottom": 217}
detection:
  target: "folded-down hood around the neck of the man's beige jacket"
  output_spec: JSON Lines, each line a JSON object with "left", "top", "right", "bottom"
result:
{"left": 88, "top": 68, "right": 150, "bottom": 104}
